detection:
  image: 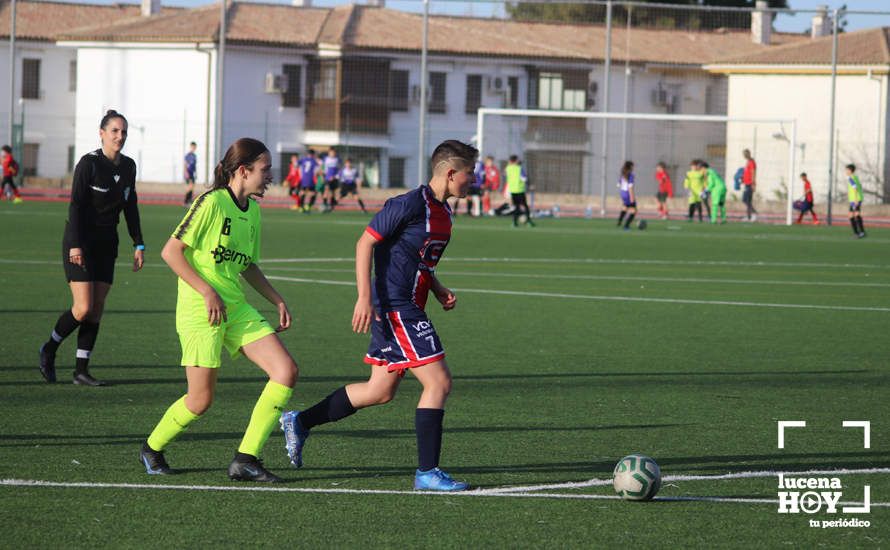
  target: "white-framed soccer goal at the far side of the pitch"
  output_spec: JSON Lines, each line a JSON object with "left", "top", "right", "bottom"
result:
{"left": 476, "top": 107, "right": 799, "bottom": 225}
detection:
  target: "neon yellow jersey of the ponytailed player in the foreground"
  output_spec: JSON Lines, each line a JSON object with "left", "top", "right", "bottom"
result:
{"left": 173, "top": 187, "right": 260, "bottom": 314}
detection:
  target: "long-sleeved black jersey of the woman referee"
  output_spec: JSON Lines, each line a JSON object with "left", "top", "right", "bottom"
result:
{"left": 64, "top": 149, "right": 144, "bottom": 250}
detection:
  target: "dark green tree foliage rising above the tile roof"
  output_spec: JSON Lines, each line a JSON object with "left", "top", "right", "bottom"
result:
{"left": 507, "top": 0, "right": 788, "bottom": 30}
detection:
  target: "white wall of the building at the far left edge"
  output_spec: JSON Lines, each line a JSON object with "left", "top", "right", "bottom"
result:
{"left": 0, "top": 40, "right": 75, "bottom": 177}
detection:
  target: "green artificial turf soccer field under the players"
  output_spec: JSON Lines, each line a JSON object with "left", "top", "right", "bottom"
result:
{"left": 0, "top": 202, "right": 890, "bottom": 548}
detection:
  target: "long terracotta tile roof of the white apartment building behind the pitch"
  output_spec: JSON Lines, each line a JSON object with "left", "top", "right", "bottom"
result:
{"left": 0, "top": 0, "right": 812, "bottom": 65}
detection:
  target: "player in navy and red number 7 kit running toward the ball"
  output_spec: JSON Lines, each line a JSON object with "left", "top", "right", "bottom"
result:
{"left": 281, "top": 140, "right": 479, "bottom": 491}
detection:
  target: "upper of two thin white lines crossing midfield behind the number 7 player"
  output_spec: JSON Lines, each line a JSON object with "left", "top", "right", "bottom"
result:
{"left": 260, "top": 267, "right": 890, "bottom": 288}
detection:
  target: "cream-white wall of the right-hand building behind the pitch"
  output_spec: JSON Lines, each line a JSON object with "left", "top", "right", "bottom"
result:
{"left": 727, "top": 74, "right": 887, "bottom": 202}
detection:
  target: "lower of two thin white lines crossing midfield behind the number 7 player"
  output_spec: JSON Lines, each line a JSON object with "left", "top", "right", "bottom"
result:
{"left": 266, "top": 275, "right": 890, "bottom": 313}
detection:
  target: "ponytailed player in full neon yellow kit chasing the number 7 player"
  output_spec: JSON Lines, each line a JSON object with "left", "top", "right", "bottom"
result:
{"left": 140, "top": 138, "right": 297, "bottom": 482}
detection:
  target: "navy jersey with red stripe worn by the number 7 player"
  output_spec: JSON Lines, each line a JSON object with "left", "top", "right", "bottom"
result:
{"left": 365, "top": 185, "right": 451, "bottom": 312}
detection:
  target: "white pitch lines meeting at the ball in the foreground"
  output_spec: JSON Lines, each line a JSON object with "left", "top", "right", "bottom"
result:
{"left": 0, "top": 468, "right": 890, "bottom": 508}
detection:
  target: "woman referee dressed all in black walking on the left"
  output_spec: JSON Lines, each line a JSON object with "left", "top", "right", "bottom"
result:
{"left": 40, "top": 110, "right": 145, "bottom": 386}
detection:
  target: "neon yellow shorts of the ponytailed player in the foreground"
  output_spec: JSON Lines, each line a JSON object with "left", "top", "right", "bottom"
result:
{"left": 176, "top": 302, "right": 275, "bottom": 369}
